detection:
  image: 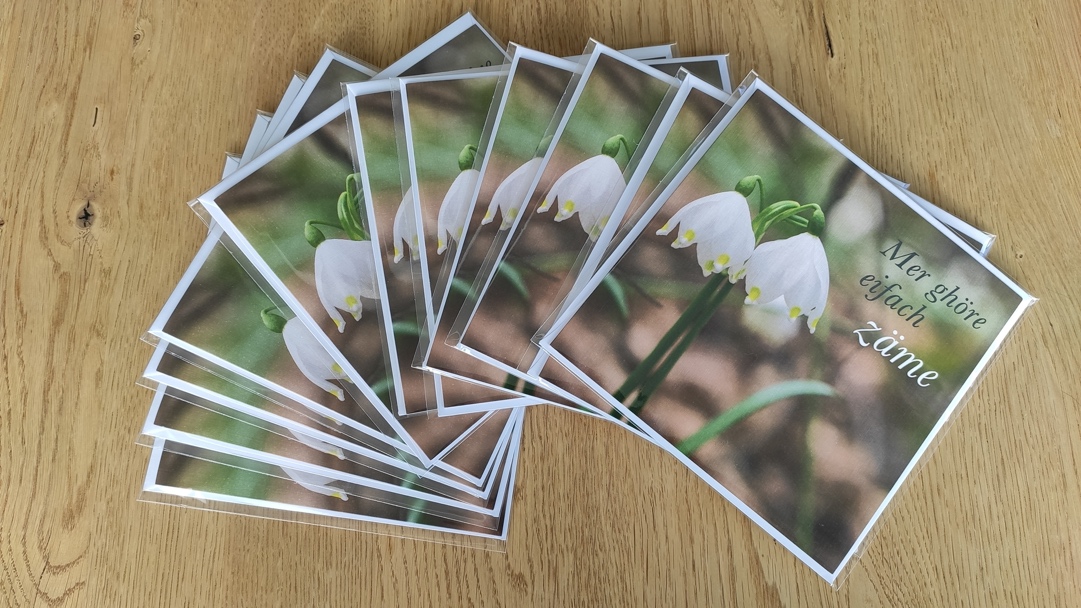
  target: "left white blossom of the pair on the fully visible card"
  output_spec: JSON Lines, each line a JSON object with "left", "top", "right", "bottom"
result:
{"left": 657, "top": 191, "right": 755, "bottom": 282}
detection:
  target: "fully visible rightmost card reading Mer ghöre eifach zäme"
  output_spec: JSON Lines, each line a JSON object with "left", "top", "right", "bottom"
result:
{"left": 542, "top": 80, "right": 1033, "bottom": 581}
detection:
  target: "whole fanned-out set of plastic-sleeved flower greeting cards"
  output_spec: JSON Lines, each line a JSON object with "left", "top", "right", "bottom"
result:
{"left": 143, "top": 15, "right": 1033, "bottom": 582}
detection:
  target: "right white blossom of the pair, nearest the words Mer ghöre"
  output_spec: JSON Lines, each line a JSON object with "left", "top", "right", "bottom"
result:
{"left": 746, "top": 233, "right": 829, "bottom": 333}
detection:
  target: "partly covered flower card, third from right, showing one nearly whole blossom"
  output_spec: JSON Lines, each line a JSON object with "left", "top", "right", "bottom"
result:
{"left": 449, "top": 43, "right": 704, "bottom": 410}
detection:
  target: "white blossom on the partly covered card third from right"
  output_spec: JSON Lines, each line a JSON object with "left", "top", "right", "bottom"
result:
{"left": 537, "top": 154, "right": 627, "bottom": 240}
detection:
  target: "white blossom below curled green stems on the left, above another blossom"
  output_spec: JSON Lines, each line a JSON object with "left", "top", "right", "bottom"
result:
{"left": 316, "top": 239, "right": 379, "bottom": 332}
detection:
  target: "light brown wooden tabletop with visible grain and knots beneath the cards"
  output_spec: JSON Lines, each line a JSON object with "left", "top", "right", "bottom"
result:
{"left": 0, "top": 0, "right": 1081, "bottom": 607}
